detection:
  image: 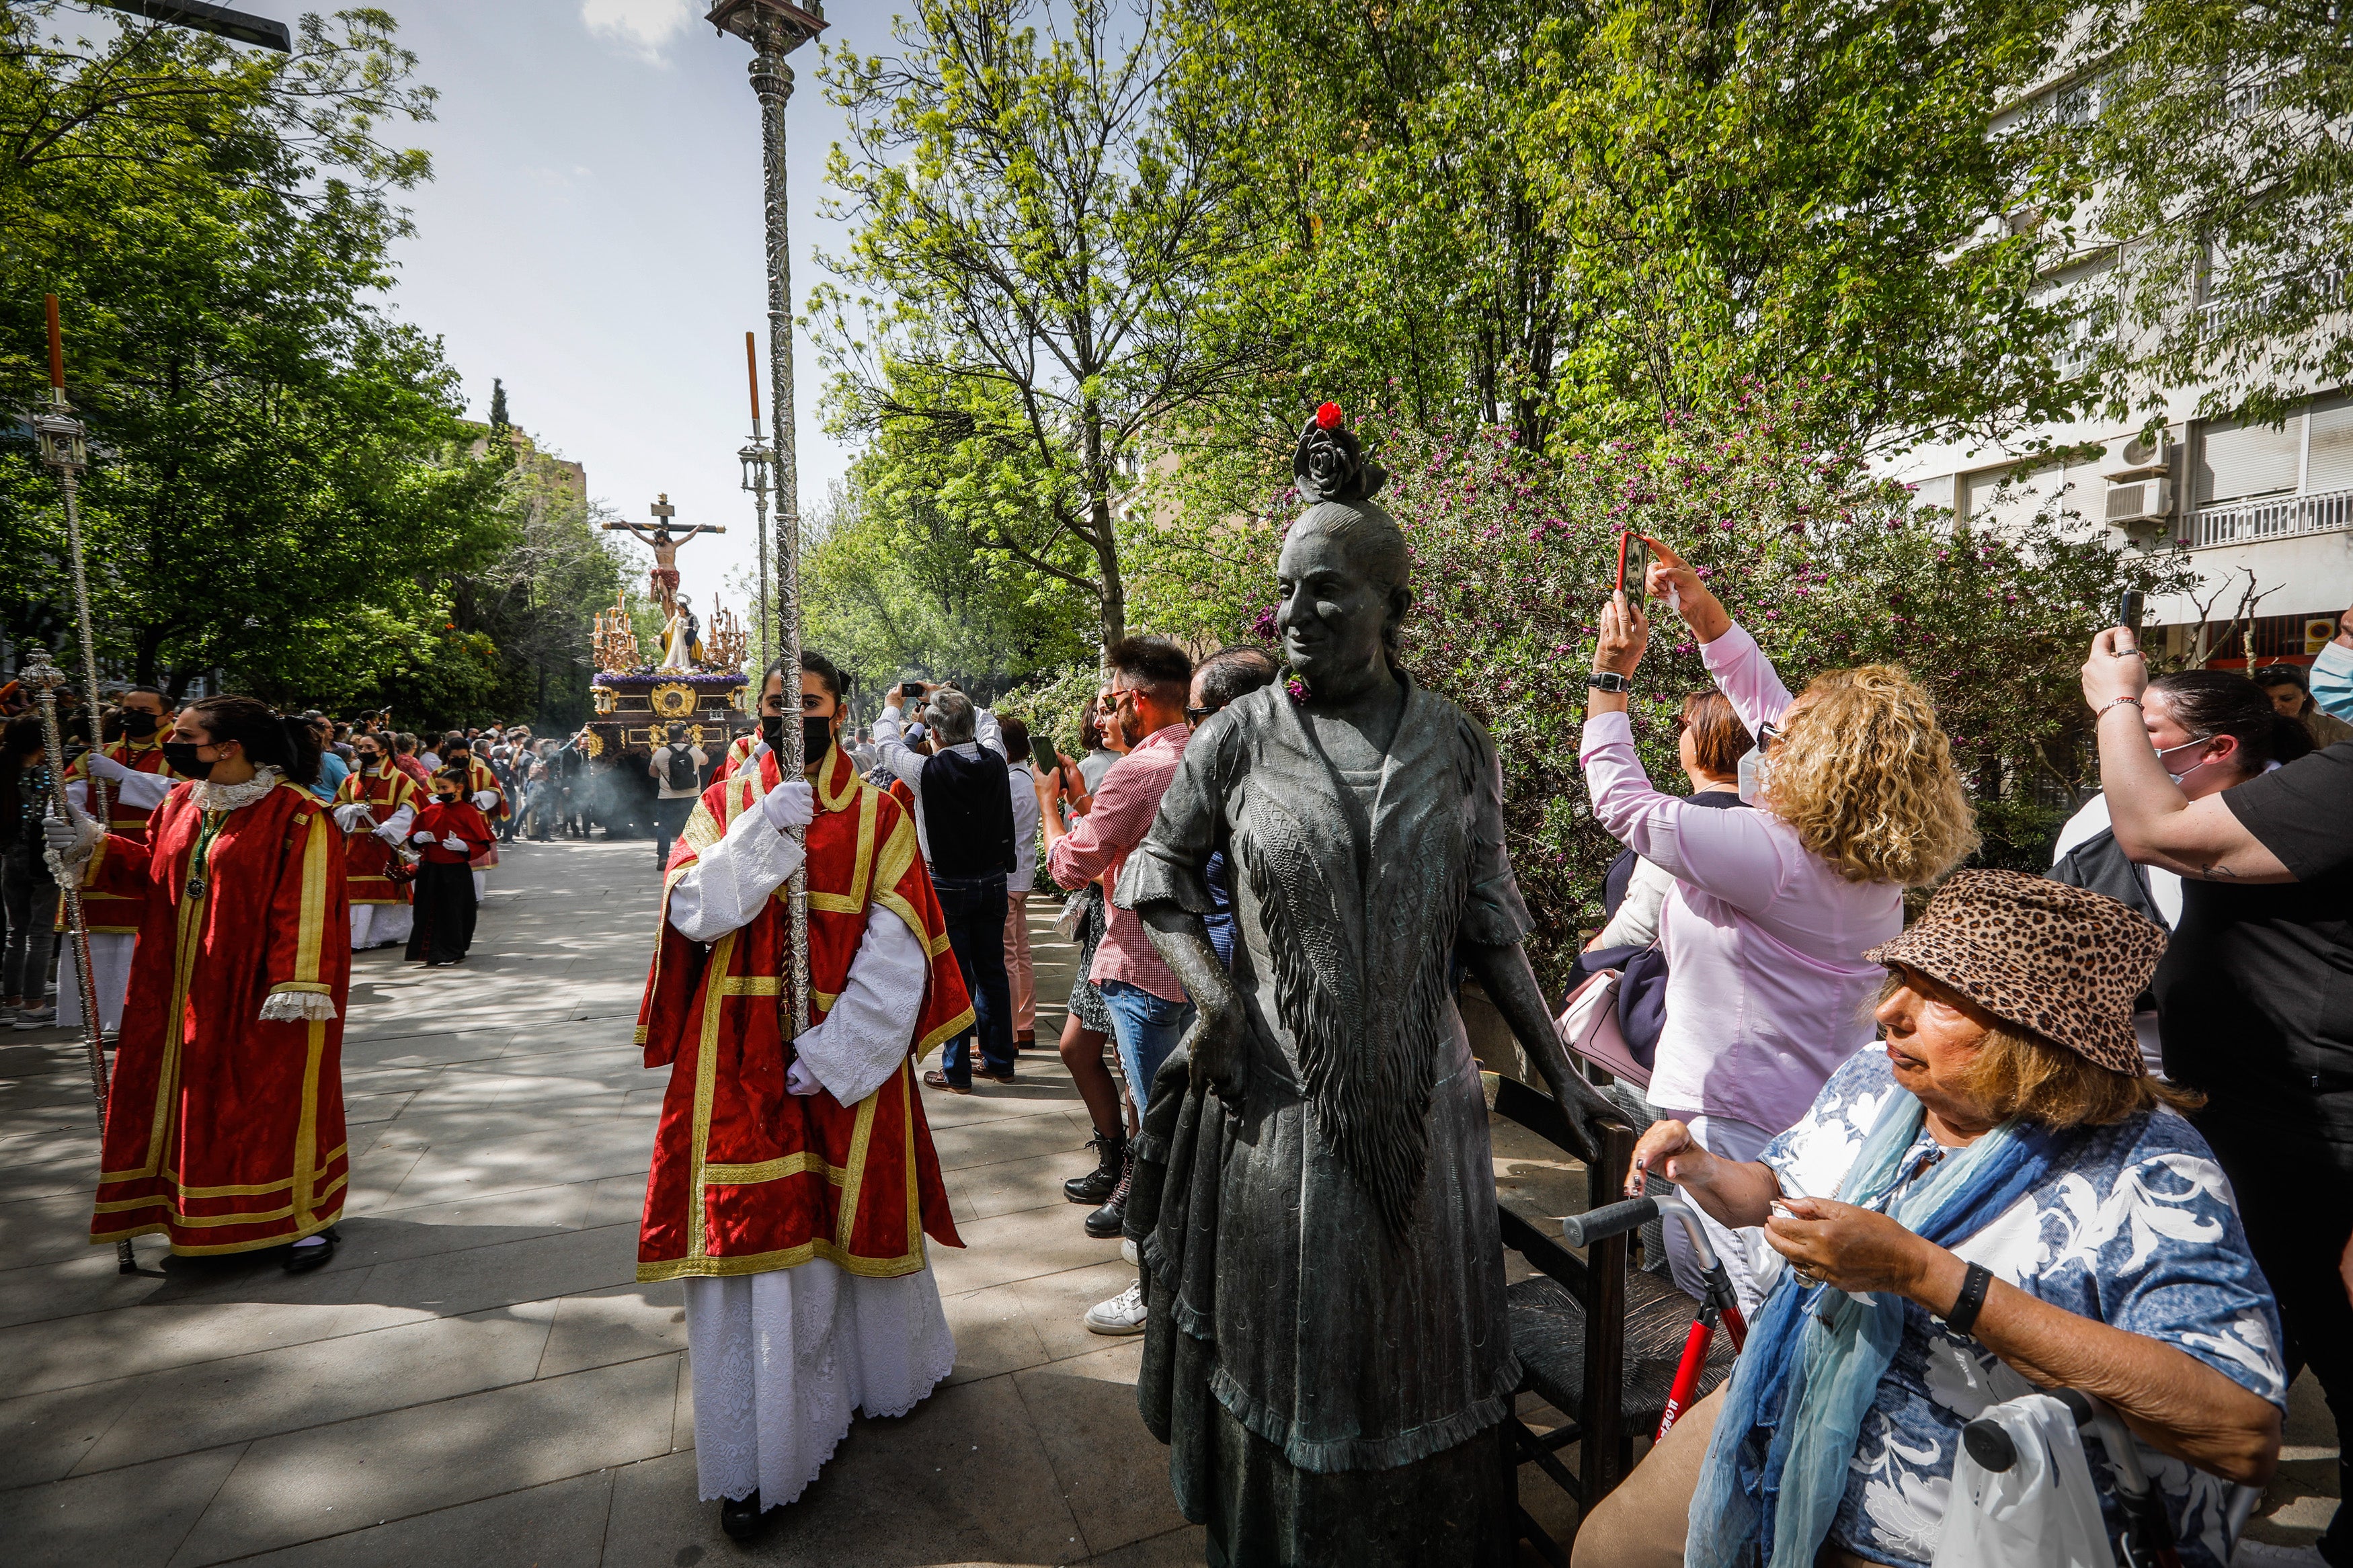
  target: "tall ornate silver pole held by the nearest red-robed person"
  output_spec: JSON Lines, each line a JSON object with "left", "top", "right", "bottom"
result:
{"left": 709, "top": 0, "right": 826, "bottom": 1039}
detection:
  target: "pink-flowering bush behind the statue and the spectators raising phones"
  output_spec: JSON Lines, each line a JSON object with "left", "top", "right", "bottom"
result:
{"left": 1146, "top": 395, "right": 2186, "bottom": 978}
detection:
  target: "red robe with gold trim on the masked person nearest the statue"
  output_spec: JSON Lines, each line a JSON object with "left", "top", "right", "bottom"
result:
{"left": 638, "top": 747, "right": 972, "bottom": 1281}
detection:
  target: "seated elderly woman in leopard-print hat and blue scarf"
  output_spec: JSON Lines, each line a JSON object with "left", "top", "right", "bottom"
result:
{"left": 1577, "top": 872, "right": 2287, "bottom": 1568}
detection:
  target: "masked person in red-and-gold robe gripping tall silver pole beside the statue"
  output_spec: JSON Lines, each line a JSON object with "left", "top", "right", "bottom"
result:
{"left": 638, "top": 649, "right": 972, "bottom": 1540}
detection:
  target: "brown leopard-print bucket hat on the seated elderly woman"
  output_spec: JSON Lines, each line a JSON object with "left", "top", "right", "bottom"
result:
{"left": 1864, "top": 872, "right": 2165, "bottom": 1077}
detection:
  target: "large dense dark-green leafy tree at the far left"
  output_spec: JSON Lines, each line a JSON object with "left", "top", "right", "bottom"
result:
{"left": 0, "top": 5, "right": 508, "bottom": 691}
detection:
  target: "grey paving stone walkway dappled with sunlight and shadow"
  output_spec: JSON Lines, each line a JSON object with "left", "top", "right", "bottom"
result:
{"left": 0, "top": 841, "right": 2334, "bottom": 1568}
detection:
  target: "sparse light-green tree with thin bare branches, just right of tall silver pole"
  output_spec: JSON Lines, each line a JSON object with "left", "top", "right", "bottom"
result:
{"left": 817, "top": 0, "right": 1254, "bottom": 639}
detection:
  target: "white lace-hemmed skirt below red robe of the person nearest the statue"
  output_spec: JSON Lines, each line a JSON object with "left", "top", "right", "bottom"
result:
{"left": 685, "top": 1257, "right": 955, "bottom": 1507}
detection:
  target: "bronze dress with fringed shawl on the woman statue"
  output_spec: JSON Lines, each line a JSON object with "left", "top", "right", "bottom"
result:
{"left": 1118, "top": 686, "right": 1529, "bottom": 1472}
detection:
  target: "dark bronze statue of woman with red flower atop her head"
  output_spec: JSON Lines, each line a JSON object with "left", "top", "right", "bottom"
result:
{"left": 1118, "top": 405, "right": 1617, "bottom": 1568}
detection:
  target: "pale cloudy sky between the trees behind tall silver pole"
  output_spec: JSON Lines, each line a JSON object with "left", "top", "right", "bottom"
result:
{"left": 218, "top": 0, "right": 894, "bottom": 614}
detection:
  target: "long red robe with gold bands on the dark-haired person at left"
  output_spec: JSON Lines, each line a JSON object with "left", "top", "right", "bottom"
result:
{"left": 85, "top": 783, "right": 351, "bottom": 1253}
